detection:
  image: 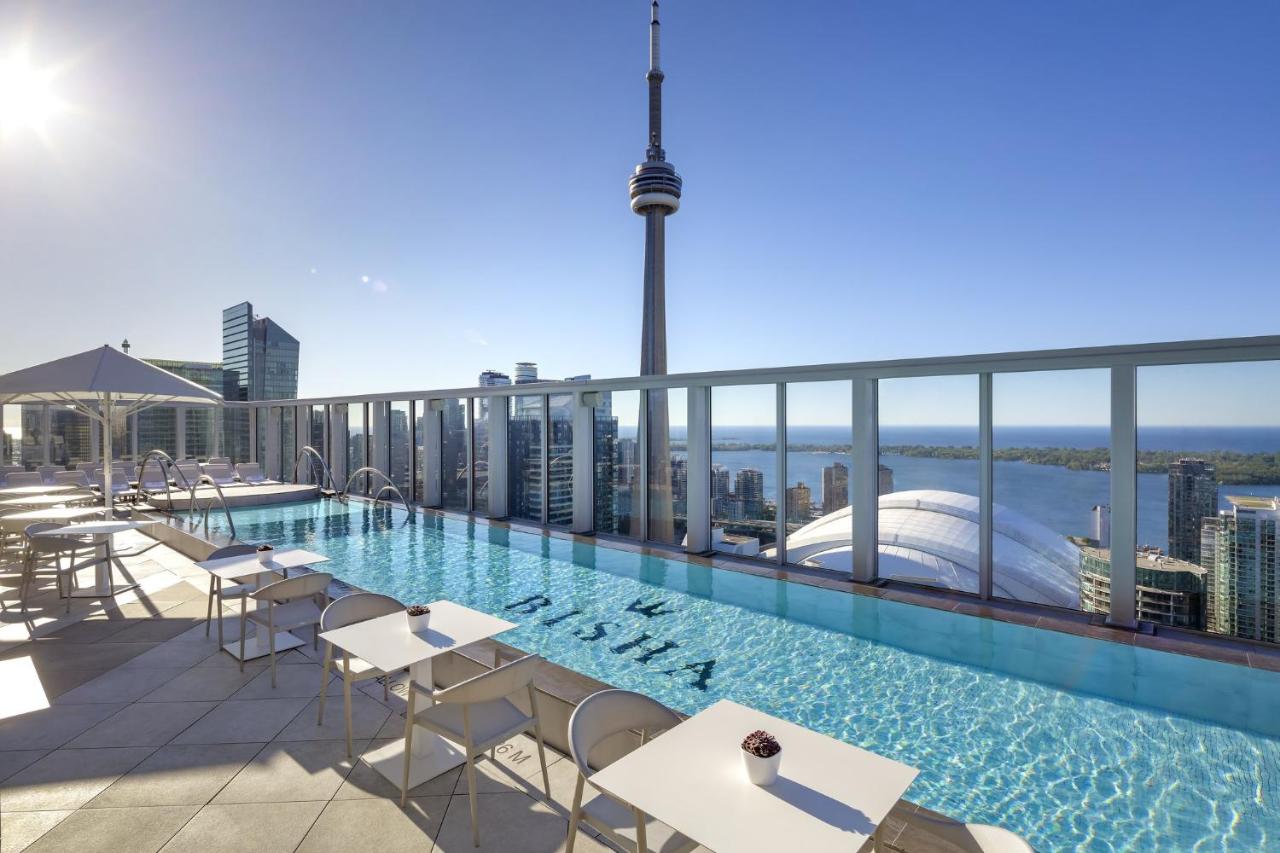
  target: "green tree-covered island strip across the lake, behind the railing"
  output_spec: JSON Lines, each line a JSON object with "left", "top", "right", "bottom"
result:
{"left": 691, "top": 441, "right": 1280, "bottom": 485}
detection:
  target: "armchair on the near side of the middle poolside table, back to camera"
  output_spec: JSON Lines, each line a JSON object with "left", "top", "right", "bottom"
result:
{"left": 401, "top": 654, "right": 552, "bottom": 847}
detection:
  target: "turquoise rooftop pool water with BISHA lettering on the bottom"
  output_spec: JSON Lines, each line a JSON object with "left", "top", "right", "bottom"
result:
{"left": 212, "top": 501, "right": 1280, "bottom": 852}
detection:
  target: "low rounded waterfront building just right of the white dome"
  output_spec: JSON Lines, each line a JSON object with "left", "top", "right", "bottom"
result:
{"left": 1080, "top": 546, "right": 1208, "bottom": 629}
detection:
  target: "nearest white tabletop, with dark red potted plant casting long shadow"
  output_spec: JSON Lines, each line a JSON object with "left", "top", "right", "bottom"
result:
{"left": 590, "top": 699, "right": 919, "bottom": 853}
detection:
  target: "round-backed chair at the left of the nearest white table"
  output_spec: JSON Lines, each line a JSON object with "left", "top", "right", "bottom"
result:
{"left": 564, "top": 690, "right": 698, "bottom": 853}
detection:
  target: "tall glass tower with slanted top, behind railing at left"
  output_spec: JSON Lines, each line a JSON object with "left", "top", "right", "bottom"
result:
{"left": 223, "top": 302, "right": 301, "bottom": 461}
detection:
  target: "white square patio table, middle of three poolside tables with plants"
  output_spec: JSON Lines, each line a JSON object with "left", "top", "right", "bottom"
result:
{"left": 320, "top": 601, "right": 518, "bottom": 788}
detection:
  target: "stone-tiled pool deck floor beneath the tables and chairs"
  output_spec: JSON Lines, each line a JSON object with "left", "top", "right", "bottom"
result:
{"left": 0, "top": 535, "right": 942, "bottom": 853}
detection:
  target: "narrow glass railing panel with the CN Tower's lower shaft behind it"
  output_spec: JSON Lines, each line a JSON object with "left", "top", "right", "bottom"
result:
{"left": 646, "top": 388, "right": 689, "bottom": 544}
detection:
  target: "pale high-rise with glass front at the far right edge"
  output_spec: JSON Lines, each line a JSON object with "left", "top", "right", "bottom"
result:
{"left": 1202, "top": 496, "right": 1280, "bottom": 643}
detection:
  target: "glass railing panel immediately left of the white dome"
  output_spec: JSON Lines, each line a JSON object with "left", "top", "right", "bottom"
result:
{"left": 711, "top": 386, "right": 778, "bottom": 558}
